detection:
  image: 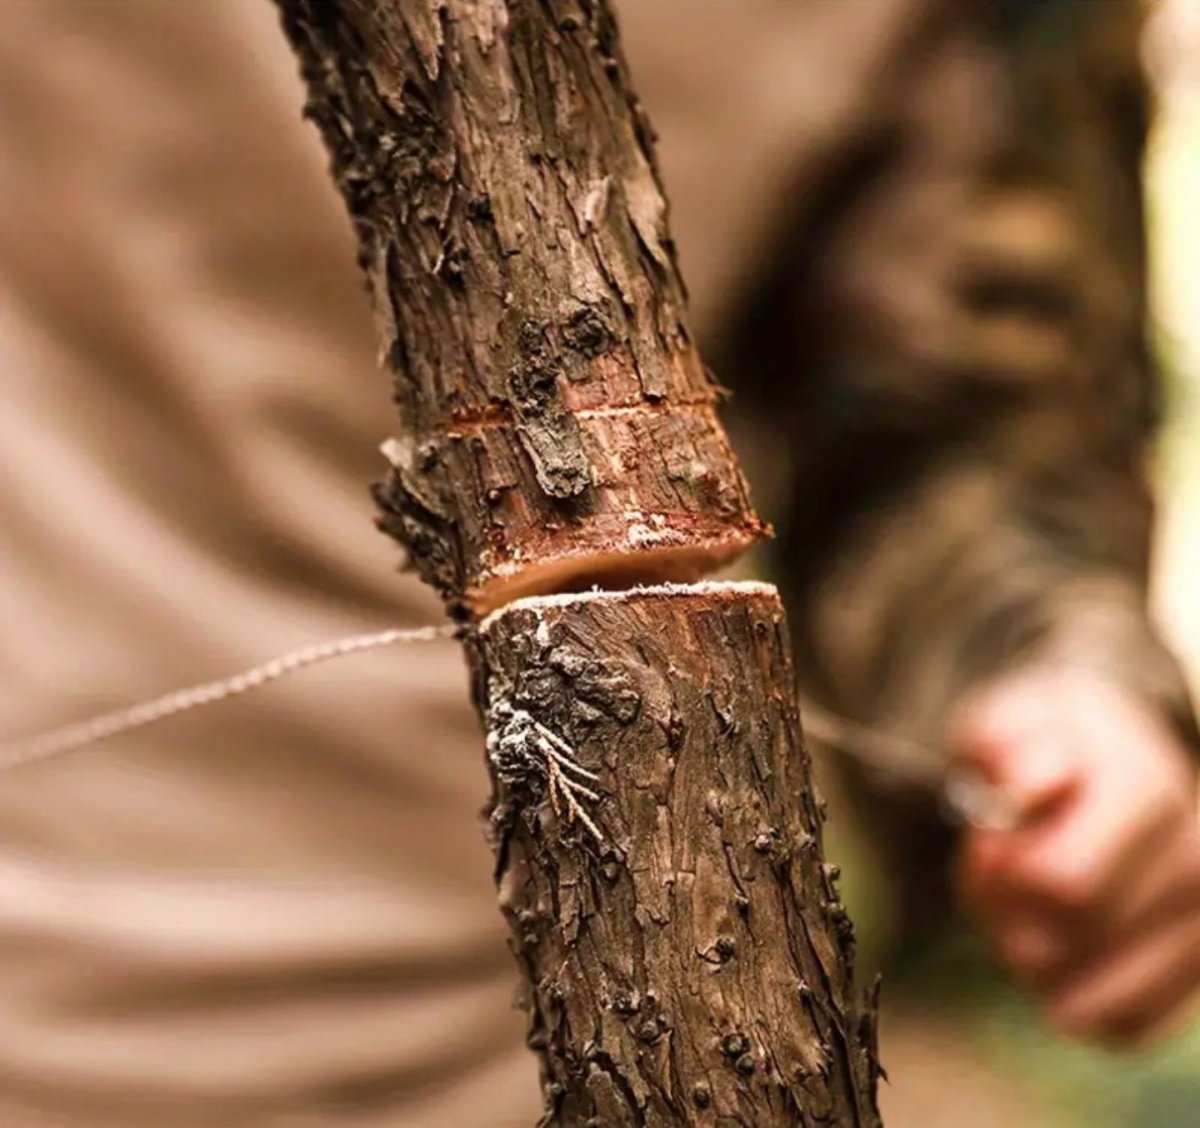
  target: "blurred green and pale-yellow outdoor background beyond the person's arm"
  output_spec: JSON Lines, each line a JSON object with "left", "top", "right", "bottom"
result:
{"left": 849, "top": 0, "right": 1200, "bottom": 1128}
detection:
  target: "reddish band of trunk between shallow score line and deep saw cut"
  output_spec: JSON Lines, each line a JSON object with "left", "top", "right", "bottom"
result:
{"left": 377, "top": 404, "right": 762, "bottom": 614}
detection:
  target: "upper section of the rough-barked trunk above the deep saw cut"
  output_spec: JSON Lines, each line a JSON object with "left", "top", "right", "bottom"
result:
{"left": 280, "top": 0, "right": 761, "bottom": 611}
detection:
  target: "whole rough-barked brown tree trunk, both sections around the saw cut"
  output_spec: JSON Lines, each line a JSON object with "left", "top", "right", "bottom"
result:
{"left": 276, "top": 0, "right": 878, "bottom": 1128}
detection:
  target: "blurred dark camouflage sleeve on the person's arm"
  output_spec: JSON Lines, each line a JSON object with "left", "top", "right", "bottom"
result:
{"left": 724, "top": 2, "right": 1192, "bottom": 768}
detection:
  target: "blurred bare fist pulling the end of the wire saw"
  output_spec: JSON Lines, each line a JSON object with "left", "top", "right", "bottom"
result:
{"left": 950, "top": 671, "right": 1200, "bottom": 1048}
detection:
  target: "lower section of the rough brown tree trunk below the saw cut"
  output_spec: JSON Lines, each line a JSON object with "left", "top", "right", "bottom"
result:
{"left": 475, "top": 584, "right": 878, "bottom": 1128}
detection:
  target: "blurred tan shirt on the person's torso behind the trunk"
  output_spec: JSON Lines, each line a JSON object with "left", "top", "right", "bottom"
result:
{"left": 0, "top": 0, "right": 1185, "bottom": 1128}
